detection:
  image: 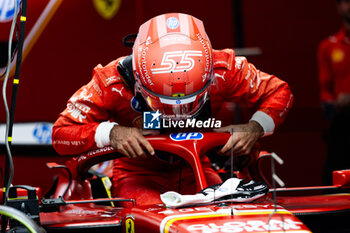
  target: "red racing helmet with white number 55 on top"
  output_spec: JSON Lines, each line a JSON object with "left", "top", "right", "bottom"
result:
{"left": 133, "top": 13, "right": 213, "bottom": 119}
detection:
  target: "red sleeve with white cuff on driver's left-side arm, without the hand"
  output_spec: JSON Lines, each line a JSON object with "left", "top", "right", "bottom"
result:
{"left": 52, "top": 70, "right": 116, "bottom": 155}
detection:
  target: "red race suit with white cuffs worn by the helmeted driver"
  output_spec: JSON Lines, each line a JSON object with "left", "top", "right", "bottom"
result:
{"left": 52, "top": 49, "right": 293, "bottom": 204}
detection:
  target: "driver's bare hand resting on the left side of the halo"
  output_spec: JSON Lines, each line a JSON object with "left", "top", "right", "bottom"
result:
{"left": 109, "top": 125, "right": 155, "bottom": 158}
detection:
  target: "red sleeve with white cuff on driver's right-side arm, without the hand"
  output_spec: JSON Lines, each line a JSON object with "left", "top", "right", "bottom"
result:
{"left": 224, "top": 54, "right": 293, "bottom": 136}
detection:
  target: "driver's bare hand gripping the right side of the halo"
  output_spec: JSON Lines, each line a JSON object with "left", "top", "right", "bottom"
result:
{"left": 214, "top": 121, "right": 264, "bottom": 155}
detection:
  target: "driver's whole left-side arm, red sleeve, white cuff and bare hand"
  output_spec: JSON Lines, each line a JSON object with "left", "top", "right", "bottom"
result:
{"left": 52, "top": 63, "right": 154, "bottom": 157}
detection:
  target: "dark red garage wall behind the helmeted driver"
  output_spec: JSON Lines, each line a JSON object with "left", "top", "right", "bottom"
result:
{"left": 0, "top": 0, "right": 341, "bottom": 192}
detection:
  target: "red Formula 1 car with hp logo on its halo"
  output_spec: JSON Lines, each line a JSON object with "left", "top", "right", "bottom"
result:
{"left": 2, "top": 132, "right": 350, "bottom": 233}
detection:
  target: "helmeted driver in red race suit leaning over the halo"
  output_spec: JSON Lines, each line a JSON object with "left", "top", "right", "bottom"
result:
{"left": 52, "top": 13, "right": 293, "bottom": 205}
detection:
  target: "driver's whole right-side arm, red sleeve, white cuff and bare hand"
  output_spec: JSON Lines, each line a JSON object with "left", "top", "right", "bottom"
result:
{"left": 213, "top": 50, "right": 293, "bottom": 155}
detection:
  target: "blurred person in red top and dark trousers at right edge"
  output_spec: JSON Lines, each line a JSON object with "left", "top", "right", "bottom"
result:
{"left": 317, "top": 0, "right": 350, "bottom": 185}
